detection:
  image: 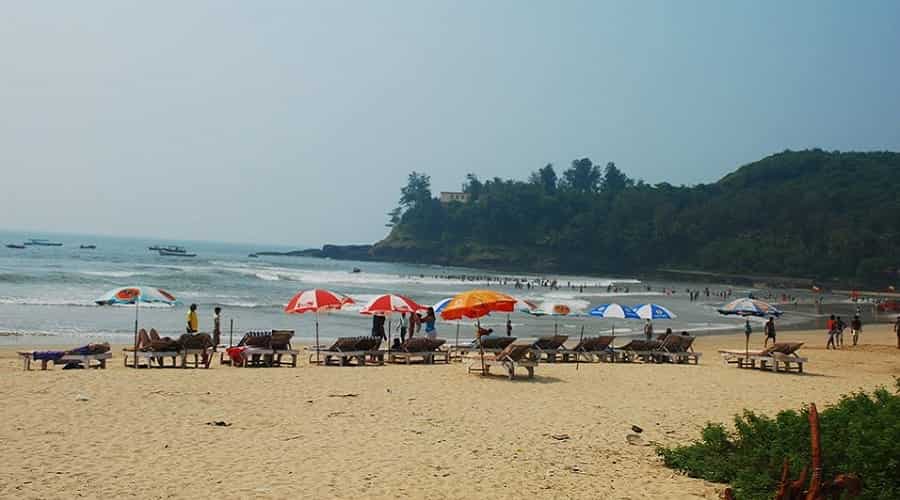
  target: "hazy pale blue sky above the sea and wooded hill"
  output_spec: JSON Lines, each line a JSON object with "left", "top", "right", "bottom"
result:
{"left": 0, "top": 0, "right": 900, "bottom": 245}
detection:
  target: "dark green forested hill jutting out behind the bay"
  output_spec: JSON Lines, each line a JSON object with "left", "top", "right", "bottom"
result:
{"left": 371, "top": 150, "right": 900, "bottom": 285}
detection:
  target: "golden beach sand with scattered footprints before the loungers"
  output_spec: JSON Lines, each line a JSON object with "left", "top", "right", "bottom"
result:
{"left": 0, "top": 325, "right": 900, "bottom": 499}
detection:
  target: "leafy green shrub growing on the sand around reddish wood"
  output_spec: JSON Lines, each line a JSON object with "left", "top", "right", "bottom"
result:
{"left": 657, "top": 379, "right": 900, "bottom": 500}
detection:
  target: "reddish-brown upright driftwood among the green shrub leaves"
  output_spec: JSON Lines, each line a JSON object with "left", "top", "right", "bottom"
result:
{"left": 720, "top": 404, "right": 862, "bottom": 500}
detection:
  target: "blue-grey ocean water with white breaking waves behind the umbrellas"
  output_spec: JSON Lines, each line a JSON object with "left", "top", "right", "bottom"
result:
{"left": 0, "top": 232, "right": 810, "bottom": 345}
